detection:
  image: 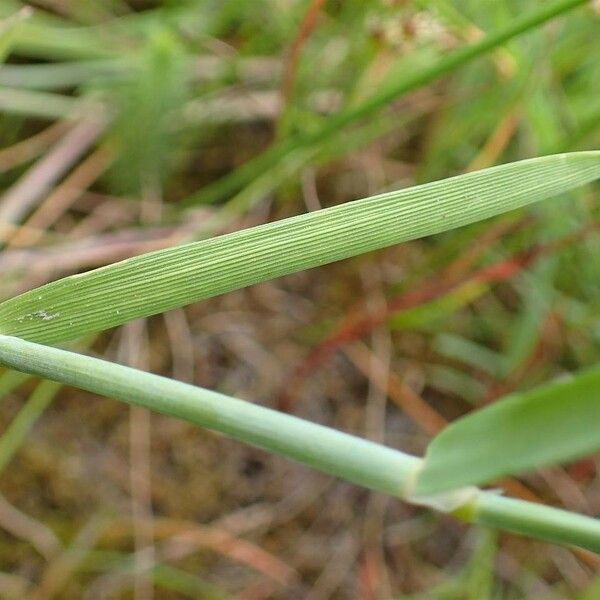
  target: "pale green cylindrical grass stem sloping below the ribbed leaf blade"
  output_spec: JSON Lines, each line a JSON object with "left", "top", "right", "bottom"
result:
{"left": 0, "top": 336, "right": 600, "bottom": 552}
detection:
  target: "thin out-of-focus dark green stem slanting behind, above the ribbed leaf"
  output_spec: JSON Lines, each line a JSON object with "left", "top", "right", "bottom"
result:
{"left": 183, "top": 0, "right": 586, "bottom": 205}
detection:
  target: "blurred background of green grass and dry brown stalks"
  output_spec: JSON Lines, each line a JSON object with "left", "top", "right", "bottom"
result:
{"left": 0, "top": 0, "right": 600, "bottom": 598}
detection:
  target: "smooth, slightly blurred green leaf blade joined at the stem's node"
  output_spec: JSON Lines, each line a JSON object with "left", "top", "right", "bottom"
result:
{"left": 415, "top": 367, "right": 600, "bottom": 495}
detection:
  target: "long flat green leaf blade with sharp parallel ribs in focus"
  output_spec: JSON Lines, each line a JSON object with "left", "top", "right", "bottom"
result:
{"left": 0, "top": 152, "right": 600, "bottom": 343}
